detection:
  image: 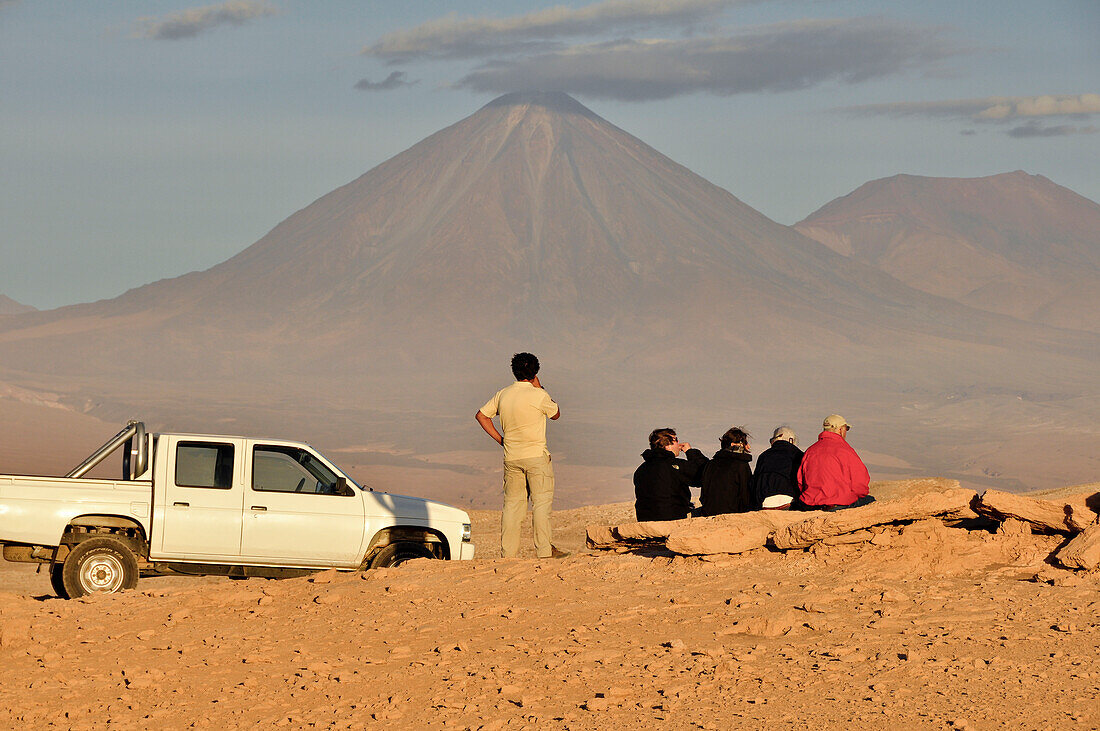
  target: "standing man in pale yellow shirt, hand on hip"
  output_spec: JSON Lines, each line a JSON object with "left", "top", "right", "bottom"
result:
{"left": 474, "top": 353, "right": 569, "bottom": 558}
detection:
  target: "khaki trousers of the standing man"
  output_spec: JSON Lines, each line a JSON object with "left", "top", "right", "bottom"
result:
{"left": 501, "top": 455, "right": 553, "bottom": 558}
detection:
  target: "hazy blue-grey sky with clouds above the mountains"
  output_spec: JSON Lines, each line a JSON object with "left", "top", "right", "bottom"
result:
{"left": 0, "top": 0, "right": 1100, "bottom": 309}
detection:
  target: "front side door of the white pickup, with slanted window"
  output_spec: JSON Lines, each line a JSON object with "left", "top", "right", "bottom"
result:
{"left": 241, "top": 441, "right": 363, "bottom": 567}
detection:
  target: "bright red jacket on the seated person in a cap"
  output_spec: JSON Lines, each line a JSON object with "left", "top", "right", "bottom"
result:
{"left": 799, "top": 432, "right": 871, "bottom": 506}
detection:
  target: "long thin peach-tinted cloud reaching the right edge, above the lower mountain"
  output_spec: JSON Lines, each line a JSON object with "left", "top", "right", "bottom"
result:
{"left": 844, "top": 93, "right": 1100, "bottom": 122}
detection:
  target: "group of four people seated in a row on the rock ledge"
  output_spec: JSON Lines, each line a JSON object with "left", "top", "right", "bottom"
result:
{"left": 634, "top": 413, "right": 875, "bottom": 521}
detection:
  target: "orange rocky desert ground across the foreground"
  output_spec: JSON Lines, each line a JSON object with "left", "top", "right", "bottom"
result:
{"left": 0, "top": 492, "right": 1100, "bottom": 730}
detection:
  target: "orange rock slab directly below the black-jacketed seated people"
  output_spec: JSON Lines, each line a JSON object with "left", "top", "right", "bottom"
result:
{"left": 664, "top": 510, "right": 806, "bottom": 556}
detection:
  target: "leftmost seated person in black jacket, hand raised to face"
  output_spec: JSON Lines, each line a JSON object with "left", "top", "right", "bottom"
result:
{"left": 634, "top": 429, "right": 707, "bottom": 522}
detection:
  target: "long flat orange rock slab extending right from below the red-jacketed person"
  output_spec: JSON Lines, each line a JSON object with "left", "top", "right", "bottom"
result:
{"left": 769, "top": 488, "right": 977, "bottom": 551}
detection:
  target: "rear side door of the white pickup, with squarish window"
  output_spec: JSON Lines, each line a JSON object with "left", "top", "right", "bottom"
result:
{"left": 157, "top": 436, "right": 244, "bottom": 558}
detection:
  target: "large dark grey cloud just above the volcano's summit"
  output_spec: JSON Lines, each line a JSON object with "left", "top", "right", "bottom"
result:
{"left": 455, "top": 18, "right": 961, "bottom": 101}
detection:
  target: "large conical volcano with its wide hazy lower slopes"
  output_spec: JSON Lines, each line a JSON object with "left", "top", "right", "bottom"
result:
{"left": 0, "top": 93, "right": 1100, "bottom": 500}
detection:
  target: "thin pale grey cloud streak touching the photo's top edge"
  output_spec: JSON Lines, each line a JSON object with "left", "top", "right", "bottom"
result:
{"left": 362, "top": 0, "right": 748, "bottom": 63}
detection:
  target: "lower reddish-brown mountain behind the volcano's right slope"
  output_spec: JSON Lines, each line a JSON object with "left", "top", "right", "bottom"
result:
{"left": 795, "top": 170, "right": 1100, "bottom": 332}
